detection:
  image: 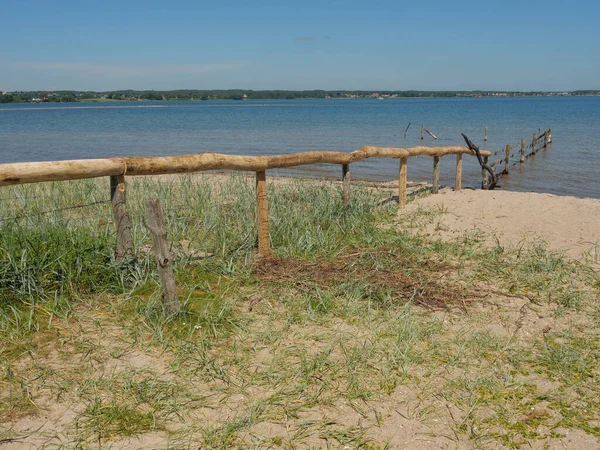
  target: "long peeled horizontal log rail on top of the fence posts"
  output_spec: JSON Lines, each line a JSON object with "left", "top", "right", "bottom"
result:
{"left": 0, "top": 146, "right": 491, "bottom": 186}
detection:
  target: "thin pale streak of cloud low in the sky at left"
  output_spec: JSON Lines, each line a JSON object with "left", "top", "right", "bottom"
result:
{"left": 12, "top": 61, "right": 250, "bottom": 78}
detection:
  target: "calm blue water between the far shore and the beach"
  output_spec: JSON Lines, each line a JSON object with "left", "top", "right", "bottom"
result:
{"left": 0, "top": 97, "right": 600, "bottom": 198}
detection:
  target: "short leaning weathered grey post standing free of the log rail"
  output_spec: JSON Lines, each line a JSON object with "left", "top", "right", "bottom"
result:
{"left": 146, "top": 198, "right": 179, "bottom": 314}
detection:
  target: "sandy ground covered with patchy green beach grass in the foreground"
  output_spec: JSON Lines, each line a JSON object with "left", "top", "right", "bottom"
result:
{"left": 0, "top": 174, "right": 600, "bottom": 449}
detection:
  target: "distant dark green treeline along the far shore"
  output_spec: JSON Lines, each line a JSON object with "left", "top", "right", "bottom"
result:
{"left": 0, "top": 89, "right": 600, "bottom": 103}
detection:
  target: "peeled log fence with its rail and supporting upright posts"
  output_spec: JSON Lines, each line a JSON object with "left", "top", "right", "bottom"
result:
{"left": 0, "top": 146, "right": 492, "bottom": 258}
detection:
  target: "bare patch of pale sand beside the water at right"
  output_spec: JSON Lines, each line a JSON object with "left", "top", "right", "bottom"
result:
{"left": 399, "top": 189, "right": 600, "bottom": 264}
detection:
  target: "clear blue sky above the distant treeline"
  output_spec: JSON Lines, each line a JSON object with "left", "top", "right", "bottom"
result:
{"left": 0, "top": 0, "right": 600, "bottom": 91}
